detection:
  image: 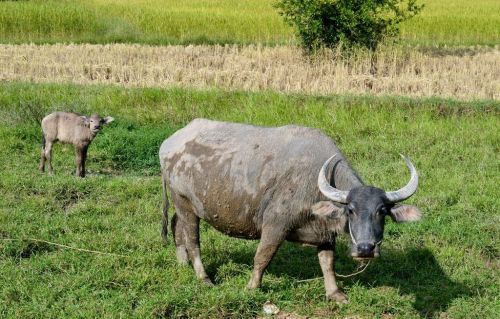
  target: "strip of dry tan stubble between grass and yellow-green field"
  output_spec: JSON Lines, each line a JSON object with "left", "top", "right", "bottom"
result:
{"left": 0, "top": 44, "right": 500, "bottom": 100}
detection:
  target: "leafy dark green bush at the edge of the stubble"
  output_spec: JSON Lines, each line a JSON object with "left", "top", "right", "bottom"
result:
{"left": 276, "top": 0, "right": 423, "bottom": 52}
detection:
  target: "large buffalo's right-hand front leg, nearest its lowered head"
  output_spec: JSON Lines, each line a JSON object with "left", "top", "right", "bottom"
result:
{"left": 318, "top": 244, "right": 347, "bottom": 303}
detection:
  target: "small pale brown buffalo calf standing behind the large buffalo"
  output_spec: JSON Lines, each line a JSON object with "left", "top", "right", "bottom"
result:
{"left": 40, "top": 112, "right": 114, "bottom": 177}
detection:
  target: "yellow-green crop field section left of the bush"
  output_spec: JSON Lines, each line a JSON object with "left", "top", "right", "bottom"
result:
{"left": 0, "top": 0, "right": 290, "bottom": 44}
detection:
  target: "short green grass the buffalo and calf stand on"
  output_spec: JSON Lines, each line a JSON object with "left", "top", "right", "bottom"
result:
{"left": 0, "top": 83, "right": 500, "bottom": 318}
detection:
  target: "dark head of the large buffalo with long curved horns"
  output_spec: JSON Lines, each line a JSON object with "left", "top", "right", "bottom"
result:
{"left": 313, "top": 155, "right": 421, "bottom": 259}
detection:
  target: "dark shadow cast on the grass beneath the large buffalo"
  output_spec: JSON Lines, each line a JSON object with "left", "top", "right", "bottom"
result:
{"left": 207, "top": 242, "right": 472, "bottom": 318}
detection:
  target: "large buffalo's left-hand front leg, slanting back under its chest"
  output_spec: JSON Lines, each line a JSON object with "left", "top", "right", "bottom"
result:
{"left": 247, "top": 227, "right": 285, "bottom": 289}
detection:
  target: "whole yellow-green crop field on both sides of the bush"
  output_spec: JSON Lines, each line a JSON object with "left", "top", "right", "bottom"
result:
{"left": 0, "top": 0, "right": 500, "bottom": 46}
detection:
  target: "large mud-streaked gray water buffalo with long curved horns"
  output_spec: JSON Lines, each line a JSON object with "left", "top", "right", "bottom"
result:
{"left": 159, "top": 119, "right": 421, "bottom": 302}
